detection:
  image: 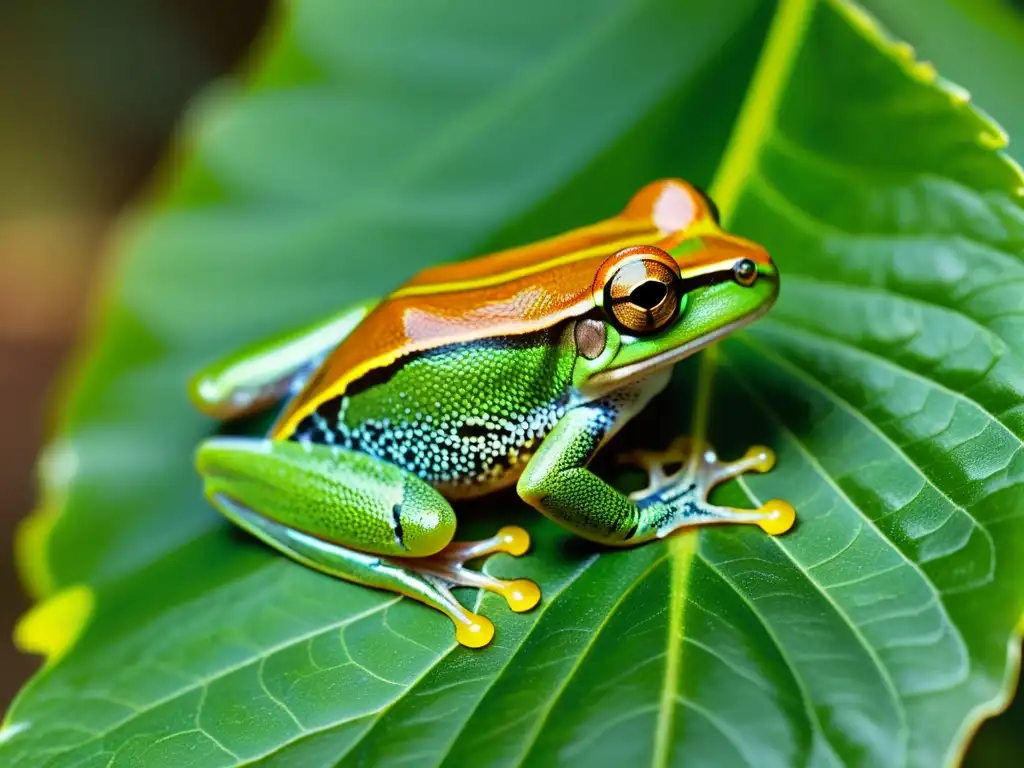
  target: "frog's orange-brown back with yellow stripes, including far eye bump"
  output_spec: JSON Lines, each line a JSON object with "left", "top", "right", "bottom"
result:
{"left": 271, "top": 180, "right": 692, "bottom": 439}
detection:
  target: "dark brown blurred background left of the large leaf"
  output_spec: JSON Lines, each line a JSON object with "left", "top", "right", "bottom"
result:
{"left": 0, "top": 0, "right": 267, "bottom": 713}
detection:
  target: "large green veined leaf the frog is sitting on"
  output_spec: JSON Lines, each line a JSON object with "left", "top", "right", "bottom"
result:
{"left": 0, "top": 0, "right": 1024, "bottom": 766}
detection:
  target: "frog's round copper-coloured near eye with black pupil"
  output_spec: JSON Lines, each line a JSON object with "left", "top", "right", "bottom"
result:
{"left": 604, "top": 246, "right": 680, "bottom": 335}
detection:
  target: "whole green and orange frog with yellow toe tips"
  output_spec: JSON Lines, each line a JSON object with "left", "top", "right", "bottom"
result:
{"left": 189, "top": 178, "right": 796, "bottom": 648}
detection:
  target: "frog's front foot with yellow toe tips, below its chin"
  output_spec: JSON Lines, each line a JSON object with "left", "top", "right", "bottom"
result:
{"left": 620, "top": 437, "right": 797, "bottom": 538}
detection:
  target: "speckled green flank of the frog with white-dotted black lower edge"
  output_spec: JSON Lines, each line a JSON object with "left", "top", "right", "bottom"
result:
{"left": 290, "top": 323, "right": 577, "bottom": 498}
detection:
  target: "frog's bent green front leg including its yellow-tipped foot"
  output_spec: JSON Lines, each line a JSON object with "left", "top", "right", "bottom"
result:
{"left": 518, "top": 391, "right": 795, "bottom": 546}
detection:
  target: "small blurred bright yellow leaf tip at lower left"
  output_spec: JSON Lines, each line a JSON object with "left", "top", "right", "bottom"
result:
{"left": 14, "top": 585, "right": 95, "bottom": 666}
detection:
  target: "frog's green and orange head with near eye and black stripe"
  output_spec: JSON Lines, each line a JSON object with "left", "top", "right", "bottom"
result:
{"left": 573, "top": 198, "right": 779, "bottom": 397}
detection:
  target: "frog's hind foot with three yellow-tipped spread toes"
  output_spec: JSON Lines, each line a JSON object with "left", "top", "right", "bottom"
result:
{"left": 392, "top": 525, "right": 541, "bottom": 648}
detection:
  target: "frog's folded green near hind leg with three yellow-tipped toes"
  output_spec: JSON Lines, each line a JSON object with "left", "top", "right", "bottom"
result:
{"left": 197, "top": 437, "right": 541, "bottom": 647}
